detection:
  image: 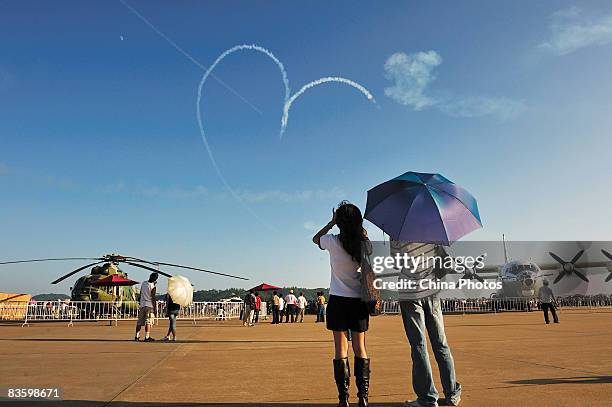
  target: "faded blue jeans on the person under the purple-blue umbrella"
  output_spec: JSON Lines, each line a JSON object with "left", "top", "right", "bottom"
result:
{"left": 400, "top": 295, "right": 461, "bottom": 406}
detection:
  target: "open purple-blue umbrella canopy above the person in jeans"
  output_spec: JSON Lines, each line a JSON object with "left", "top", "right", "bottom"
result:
{"left": 365, "top": 171, "right": 482, "bottom": 245}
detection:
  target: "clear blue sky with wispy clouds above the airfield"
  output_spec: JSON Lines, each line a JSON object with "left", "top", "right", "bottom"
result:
{"left": 0, "top": 0, "right": 612, "bottom": 292}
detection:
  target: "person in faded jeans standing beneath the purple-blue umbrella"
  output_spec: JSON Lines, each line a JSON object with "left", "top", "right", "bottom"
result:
{"left": 391, "top": 241, "right": 461, "bottom": 407}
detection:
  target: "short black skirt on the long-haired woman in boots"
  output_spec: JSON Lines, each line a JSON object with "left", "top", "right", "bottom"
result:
{"left": 326, "top": 295, "right": 370, "bottom": 332}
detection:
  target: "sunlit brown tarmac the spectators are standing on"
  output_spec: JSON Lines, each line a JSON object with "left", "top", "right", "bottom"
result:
{"left": 0, "top": 308, "right": 612, "bottom": 407}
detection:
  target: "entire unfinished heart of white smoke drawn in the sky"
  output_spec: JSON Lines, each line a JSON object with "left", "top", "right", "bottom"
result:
{"left": 196, "top": 44, "right": 376, "bottom": 229}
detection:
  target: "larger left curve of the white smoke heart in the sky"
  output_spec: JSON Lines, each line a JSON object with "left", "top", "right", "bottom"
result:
{"left": 196, "top": 44, "right": 291, "bottom": 230}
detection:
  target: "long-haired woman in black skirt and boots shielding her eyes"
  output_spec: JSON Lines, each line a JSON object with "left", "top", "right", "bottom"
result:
{"left": 312, "top": 201, "right": 370, "bottom": 407}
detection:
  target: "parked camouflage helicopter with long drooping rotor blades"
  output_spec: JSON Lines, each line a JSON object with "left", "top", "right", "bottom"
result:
{"left": 0, "top": 253, "right": 248, "bottom": 306}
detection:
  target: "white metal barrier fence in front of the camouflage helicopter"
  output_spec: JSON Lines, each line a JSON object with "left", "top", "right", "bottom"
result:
{"left": 0, "top": 301, "right": 244, "bottom": 326}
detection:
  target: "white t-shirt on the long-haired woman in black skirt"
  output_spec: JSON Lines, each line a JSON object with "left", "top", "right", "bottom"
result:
{"left": 320, "top": 234, "right": 361, "bottom": 298}
